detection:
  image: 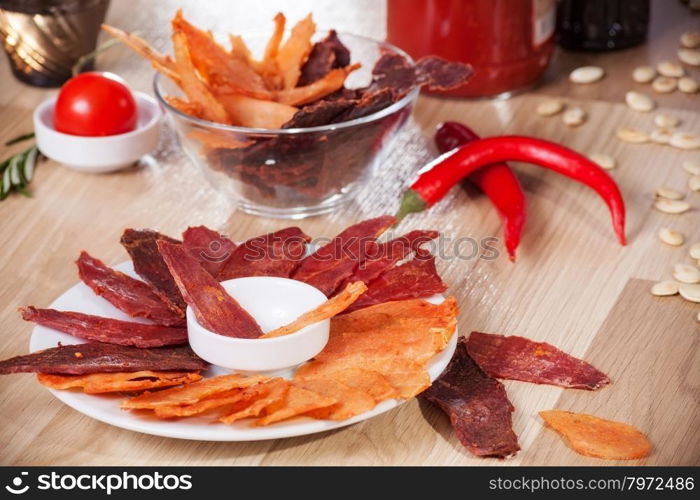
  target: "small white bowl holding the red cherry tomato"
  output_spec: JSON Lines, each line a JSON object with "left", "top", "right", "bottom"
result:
{"left": 34, "top": 92, "right": 163, "bottom": 173}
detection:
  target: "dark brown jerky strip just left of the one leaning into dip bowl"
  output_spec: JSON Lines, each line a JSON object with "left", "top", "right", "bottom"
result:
{"left": 121, "top": 229, "right": 187, "bottom": 315}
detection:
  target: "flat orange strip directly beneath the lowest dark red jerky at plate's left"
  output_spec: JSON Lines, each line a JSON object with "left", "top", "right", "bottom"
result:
{"left": 37, "top": 370, "right": 202, "bottom": 394}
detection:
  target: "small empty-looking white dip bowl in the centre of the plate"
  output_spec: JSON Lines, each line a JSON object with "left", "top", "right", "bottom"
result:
{"left": 187, "top": 276, "right": 331, "bottom": 372}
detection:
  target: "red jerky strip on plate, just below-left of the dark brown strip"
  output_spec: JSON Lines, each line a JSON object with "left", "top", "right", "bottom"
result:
{"left": 76, "top": 252, "right": 185, "bottom": 326}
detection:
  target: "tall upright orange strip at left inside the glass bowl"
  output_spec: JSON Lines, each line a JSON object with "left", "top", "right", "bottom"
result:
{"left": 173, "top": 32, "right": 231, "bottom": 124}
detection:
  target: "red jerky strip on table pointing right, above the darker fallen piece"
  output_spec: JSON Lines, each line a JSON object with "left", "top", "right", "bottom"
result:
{"left": 467, "top": 332, "right": 610, "bottom": 391}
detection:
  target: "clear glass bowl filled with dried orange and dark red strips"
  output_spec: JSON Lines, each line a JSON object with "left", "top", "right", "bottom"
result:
{"left": 154, "top": 33, "right": 419, "bottom": 219}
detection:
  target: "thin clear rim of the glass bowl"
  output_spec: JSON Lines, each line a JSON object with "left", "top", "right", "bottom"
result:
{"left": 153, "top": 32, "right": 420, "bottom": 135}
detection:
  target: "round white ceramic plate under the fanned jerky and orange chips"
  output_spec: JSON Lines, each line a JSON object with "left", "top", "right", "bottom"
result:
{"left": 29, "top": 262, "right": 457, "bottom": 441}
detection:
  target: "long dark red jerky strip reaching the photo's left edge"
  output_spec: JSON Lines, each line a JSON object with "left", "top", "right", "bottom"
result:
{"left": 0, "top": 342, "right": 208, "bottom": 375}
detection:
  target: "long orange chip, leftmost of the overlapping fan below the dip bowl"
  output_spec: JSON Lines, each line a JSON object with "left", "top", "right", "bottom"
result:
{"left": 122, "top": 373, "right": 266, "bottom": 410}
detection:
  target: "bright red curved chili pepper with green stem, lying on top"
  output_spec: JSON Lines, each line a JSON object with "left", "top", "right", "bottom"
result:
{"left": 396, "top": 135, "right": 625, "bottom": 245}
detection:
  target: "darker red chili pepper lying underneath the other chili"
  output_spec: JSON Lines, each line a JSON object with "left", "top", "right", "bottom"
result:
{"left": 435, "top": 122, "right": 527, "bottom": 262}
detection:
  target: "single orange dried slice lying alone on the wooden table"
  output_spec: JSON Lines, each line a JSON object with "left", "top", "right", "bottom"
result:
{"left": 540, "top": 410, "right": 651, "bottom": 460}
